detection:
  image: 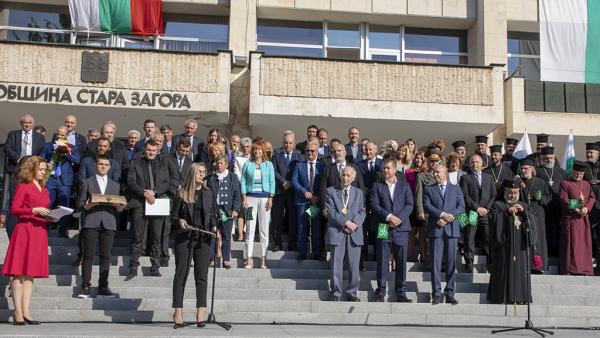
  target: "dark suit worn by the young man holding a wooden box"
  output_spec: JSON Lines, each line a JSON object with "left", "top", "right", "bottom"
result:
{"left": 78, "top": 175, "right": 120, "bottom": 288}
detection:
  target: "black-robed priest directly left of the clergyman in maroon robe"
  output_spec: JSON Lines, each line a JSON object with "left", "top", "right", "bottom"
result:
{"left": 535, "top": 146, "right": 567, "bottom": 257}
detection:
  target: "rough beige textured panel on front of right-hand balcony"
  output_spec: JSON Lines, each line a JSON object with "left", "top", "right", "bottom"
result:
{"left": 260, "top": 57, "right": 494, "bottom": 106}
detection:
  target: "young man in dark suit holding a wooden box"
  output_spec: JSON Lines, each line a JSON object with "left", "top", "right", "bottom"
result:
{"left": 77, "top": 155, "right": 123, "bottom": 298}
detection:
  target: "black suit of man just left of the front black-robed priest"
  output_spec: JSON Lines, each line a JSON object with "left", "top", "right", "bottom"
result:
{"left": 460, "top": 172, "right": 496, "bottom": 267}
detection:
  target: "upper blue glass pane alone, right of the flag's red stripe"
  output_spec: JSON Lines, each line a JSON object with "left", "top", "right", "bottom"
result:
{"left": 165, "top": 16, "right": 229, "bottom": 42}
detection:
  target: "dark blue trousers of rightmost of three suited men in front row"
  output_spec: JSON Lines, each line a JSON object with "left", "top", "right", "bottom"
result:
{"left": 429, "top": 233, "right": 458, "bottom": 298}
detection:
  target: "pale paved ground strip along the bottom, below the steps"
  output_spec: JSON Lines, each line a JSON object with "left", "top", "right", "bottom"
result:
{"left": 0, "top": 323, "right": 600, "bottom": 338}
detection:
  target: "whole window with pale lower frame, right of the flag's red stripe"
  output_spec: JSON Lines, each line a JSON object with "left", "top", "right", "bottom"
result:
{"left": 159, "top": 16, "right": 229, "bottom": 53}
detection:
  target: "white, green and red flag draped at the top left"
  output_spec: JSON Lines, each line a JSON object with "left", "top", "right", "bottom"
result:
{"left": 69, "top": 0, "right": 165, "bottom": 35}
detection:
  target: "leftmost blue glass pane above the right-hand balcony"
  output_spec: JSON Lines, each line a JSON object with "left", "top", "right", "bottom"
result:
{"left": 256, "top": 20, "right": 323, "bottom": 45}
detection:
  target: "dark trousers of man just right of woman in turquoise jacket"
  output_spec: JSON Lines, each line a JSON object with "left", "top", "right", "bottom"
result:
{"left": 270, "top": 189, "right": 298, "bottom": 250}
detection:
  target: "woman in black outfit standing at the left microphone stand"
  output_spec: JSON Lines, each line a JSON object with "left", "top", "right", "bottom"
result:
{"left": 172, "top": 163, "right": 217, "bottom": 329}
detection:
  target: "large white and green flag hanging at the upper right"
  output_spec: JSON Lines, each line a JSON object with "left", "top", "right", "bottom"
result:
{"left": 539, "top": 0, "right": 600, "bottom": 83}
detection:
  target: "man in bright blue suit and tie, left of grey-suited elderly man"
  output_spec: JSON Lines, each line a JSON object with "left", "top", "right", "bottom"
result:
{"left": 292, "top": 142, "right": 322, "bottom": 261}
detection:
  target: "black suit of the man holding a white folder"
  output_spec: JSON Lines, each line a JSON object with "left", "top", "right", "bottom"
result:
{"left": 127, "top": 157, "right": 178, "bottom": 271}
